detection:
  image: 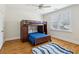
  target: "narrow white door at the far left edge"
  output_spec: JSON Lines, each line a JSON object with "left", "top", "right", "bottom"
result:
{"left": 0, "top": 4, "right": 5, "bottom": 49}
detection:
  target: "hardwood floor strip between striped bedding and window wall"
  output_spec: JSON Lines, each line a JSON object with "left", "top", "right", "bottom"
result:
{"left": 52, "top": 38, "right": 79, "bottom": 54}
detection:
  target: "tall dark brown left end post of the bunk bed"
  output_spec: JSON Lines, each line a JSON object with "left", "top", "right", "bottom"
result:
{"left": 20, "top": 20, "right": 28, "bottom": 42}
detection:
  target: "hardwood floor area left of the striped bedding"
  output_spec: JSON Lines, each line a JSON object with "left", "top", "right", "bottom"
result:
{"left": 1, "top": 39, "right": 32, "bottom": 54}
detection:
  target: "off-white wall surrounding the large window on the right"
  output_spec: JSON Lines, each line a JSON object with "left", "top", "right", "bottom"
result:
{"left": 44, "top": 5, "right": 79, "bottom": 44}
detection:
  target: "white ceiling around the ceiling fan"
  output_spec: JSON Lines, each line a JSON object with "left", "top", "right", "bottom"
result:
{"left": 32, "top": 4, "right": 71, "bottom": 14}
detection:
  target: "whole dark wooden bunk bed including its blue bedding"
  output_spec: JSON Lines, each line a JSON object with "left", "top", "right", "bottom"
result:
{"left": 20, "top": 20, "right": 51, "bottom": 45}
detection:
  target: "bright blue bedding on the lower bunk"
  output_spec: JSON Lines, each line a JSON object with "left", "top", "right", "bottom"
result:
{"left": 29, "top": 32, "right": 48, "bottom": 44}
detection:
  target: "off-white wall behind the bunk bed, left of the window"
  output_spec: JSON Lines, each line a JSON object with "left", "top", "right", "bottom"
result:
{"left": 5, "top": 4, "right": 42, "bottom": 40}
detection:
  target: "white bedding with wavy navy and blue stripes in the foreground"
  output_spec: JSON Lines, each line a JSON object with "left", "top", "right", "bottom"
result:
{"left": 32, "top": 43, "right": 73, "bottom": 54}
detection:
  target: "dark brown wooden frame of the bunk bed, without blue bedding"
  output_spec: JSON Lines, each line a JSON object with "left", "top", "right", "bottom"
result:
{"left": 20, "top": 20, "right": 51, "bottom": 45}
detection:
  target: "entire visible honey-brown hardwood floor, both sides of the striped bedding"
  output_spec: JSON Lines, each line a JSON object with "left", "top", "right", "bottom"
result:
{"left": 0, "top": 38, "right": 79, "bottom": 54}
